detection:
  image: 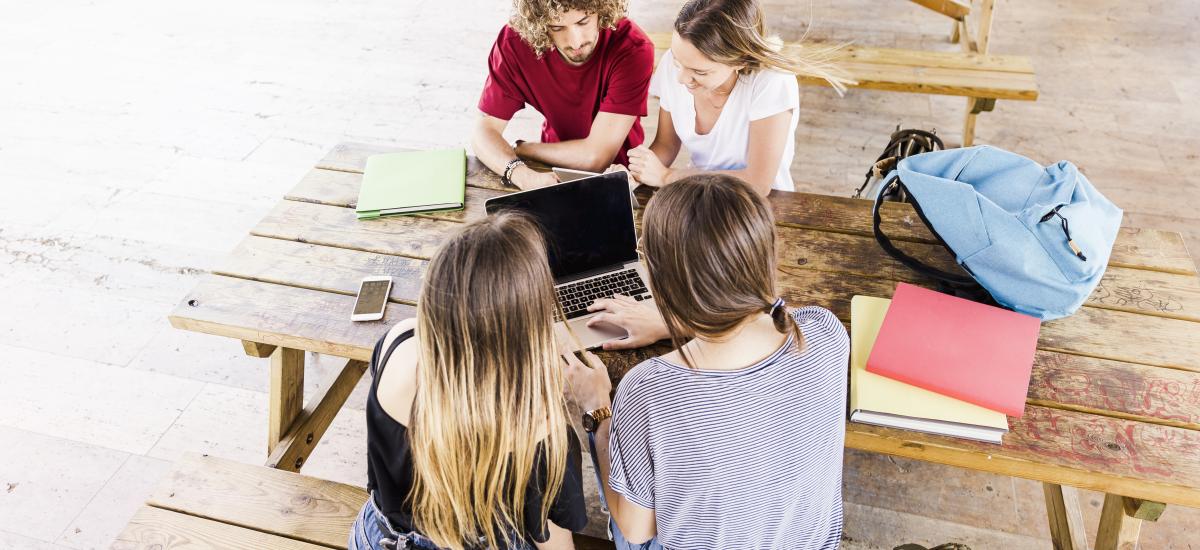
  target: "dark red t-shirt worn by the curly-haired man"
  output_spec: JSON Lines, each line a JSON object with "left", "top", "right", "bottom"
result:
{"left": 479, "top": 19, "right": 654, "bottom": 165}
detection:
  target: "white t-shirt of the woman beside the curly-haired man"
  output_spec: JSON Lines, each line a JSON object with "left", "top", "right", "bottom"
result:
{"left": 650, "top": 50, "right": 800, "bottom": 191}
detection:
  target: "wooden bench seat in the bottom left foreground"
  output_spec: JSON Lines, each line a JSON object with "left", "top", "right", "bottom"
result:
{"left": 112, "top": 455, "right": 612, "bottom": 550}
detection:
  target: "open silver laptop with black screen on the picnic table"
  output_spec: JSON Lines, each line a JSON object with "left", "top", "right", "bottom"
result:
{"left": 484, "top": 172, "right": 653, "bottom": 349}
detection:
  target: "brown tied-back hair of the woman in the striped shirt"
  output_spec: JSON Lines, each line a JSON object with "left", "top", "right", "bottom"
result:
{"left": 642, "top": 174, "right": 804, "bottom": 366}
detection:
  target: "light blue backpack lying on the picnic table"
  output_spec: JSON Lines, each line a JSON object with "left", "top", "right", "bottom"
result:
{"left": 874, "top": 145, "right": 1122, "bottom": 321}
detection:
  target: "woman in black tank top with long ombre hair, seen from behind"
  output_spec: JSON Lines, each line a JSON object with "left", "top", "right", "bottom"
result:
{"left": 348, "top": 214, "right": 587, "bottom": 550}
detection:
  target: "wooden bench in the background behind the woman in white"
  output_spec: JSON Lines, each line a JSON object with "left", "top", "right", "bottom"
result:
{"left": 649, "top": 0, "right": 1038, "bottom": 147}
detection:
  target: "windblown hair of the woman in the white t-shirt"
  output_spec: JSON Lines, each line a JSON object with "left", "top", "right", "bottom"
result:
{"left": 674, "top": 0, "right": 854, "bottom": 94}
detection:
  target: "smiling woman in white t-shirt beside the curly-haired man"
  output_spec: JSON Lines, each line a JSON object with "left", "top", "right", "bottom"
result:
{"left": 629, "top": 0, "right": 846, "bottom": 196}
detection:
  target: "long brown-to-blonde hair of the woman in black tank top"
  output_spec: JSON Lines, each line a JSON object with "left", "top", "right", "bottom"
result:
{"left": 409, "top": 214, "right": 568, "bottom": 550}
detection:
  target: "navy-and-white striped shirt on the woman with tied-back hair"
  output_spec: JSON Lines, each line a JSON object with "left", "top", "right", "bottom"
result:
{"left": 608, "top": 307, "right": 850, "bottom": 550}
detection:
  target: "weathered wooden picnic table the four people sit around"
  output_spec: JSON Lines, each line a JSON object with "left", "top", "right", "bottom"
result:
{"left": 170, "top": 143, "right": 1200, "bottom": 549}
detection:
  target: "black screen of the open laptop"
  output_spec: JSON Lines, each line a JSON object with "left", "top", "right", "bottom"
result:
{"left": 486, "top": 172, "right": 637, "bottom": 281}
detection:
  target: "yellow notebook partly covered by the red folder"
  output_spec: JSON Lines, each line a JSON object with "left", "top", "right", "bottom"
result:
{"left": 850, "top": 295, "right": 1008, "bottom": 443}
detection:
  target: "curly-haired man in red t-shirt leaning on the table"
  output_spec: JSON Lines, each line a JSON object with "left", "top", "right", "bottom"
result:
{"left": 472, "top": 0, "right": 654, "bottom": 189}
